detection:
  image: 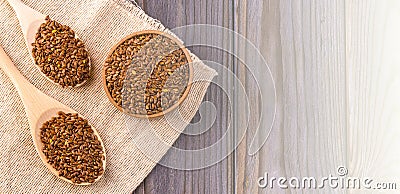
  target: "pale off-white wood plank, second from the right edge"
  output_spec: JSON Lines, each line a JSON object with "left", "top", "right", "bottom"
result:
{"left": 280, "top": 0, "right": 346, "bottom": 193}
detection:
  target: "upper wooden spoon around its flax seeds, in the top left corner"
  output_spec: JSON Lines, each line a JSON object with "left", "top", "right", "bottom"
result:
{"left": 8, "top": 0, "right": 91, "bottom": 87}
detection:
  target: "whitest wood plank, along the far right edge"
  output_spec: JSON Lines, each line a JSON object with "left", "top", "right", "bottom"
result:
{"left": 346, "top": 0, "right": 400, "bottom": 193}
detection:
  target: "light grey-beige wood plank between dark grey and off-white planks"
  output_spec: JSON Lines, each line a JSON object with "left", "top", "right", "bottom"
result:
{"left": 234, "top": 0, "right": 287, "bottom": 193}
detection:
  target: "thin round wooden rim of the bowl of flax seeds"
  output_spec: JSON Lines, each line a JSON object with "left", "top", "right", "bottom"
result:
{"left": 102, "top": 30, "right": 193, "bottom": 118}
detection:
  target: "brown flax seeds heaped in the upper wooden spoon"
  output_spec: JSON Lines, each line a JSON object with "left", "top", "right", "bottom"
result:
{"left": 32, "top": 16, "right": 90, "bottom": 87}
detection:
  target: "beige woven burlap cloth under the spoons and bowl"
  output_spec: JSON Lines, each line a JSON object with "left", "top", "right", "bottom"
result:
{"left": 0, "top": 0, "right": 216, "bottom": 193}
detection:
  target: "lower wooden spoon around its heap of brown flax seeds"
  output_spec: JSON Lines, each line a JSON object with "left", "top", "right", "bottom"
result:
{"left": 0, "top": 47, "right": 106, "bottom": 185}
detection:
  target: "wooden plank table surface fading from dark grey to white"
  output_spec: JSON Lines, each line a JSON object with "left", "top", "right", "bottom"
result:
{"left": 134, "top": 0, "right": 400, "bottom": 194}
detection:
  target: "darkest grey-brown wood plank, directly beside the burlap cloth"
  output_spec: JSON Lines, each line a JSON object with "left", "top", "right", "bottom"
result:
{"left": 135, "top": 0, "right": 233, "bottom": 193}
